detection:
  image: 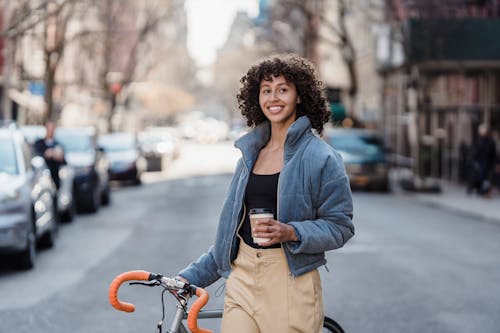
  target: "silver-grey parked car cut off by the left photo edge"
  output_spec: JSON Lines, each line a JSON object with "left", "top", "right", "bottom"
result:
{"left": 0, "top": 126, "right": 58, "bottom": 269}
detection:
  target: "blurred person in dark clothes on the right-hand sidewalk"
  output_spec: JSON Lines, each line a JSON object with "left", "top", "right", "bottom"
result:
{"left": 467, "top": 124, "right": 497, "bottom": 196}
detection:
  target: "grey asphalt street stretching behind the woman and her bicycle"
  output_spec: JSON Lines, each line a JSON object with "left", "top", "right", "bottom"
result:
{"left": 0, "top": 141, "right": 500, "bottom": 333}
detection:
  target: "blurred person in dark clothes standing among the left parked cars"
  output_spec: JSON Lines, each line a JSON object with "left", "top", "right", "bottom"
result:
{"left": 34, "top": 120, "right": 66, "bottom": 189}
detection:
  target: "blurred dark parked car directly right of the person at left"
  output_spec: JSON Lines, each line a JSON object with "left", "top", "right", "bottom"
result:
{"left": 55, "top": 127, "right": 111, "bottom": 212}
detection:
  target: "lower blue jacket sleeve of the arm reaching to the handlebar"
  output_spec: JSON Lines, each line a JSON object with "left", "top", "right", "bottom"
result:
{"left": 178, "top": 246, "right": 220, "bottom": 288}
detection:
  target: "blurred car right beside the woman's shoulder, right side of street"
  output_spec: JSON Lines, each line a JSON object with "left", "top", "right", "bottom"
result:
{"left": 324, "top": 128, "right": 390, "bottom": 191}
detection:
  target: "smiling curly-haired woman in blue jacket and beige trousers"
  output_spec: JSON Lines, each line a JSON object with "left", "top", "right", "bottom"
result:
{"left": 179, "top": 55, "right": 354, "bottom": 333}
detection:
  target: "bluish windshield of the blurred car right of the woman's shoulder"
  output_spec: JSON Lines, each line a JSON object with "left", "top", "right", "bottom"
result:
{"left": 330, "top": 135, "right": 383, "bottom": 155}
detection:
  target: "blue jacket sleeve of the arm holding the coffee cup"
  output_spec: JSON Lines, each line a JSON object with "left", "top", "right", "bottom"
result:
{"left": 286, "top": 154, "right": 354, "bottom": 254}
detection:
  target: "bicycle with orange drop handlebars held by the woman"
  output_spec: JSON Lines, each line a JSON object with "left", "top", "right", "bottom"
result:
{"left": 108, "top": 271, "right": 344, "bottom": 333}
